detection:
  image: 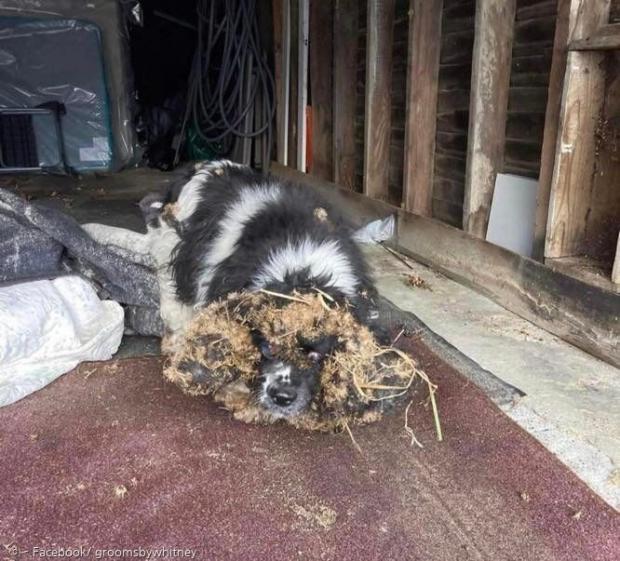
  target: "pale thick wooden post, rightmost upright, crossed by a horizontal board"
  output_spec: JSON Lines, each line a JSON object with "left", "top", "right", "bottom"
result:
{"left": 545, "top": 0, "right": 609, "bottom": 258}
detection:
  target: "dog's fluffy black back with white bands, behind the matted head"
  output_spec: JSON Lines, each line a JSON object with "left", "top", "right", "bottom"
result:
{"left": 163, "top": 162, "right": 371, "bottom": 306}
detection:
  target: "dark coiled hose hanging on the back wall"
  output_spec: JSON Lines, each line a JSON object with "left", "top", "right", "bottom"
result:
{"left": 175, "top": 0, "right": 275, "bottom": 164}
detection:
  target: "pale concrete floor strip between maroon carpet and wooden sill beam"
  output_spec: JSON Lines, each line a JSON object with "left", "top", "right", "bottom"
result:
{"left": 365, "top": 246, "right": 620, "bottom": 509}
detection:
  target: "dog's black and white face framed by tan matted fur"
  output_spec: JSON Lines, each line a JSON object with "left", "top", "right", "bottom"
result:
{"left": 254, "top": 333, "right": 338, "bottom": 418}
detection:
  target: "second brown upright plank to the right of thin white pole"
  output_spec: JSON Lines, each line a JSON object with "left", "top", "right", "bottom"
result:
{"left": 332, "top": 0, "right": 359, "bottom": 189}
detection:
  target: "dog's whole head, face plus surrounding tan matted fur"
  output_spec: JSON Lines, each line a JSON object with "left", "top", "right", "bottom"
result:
{"left": 165, "top": 292, "right": 404, "bottom": 426}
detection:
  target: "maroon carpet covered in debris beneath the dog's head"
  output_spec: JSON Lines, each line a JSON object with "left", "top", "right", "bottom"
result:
{"left": 0, "top": 341, "right": 620, "bottom": 561}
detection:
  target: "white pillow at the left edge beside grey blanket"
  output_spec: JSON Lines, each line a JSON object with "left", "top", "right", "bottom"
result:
{"left": 0, "top": 276, "right": 124, "bottom": 406}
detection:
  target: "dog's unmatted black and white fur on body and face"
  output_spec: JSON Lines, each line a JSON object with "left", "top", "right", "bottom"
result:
{"left": 141, "top": 161, "right": 376, "bottom": 416}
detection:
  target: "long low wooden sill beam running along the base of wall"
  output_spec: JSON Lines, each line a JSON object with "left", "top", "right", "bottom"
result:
{"left": 272, "top": 164, "right": 620, "bottom": 366}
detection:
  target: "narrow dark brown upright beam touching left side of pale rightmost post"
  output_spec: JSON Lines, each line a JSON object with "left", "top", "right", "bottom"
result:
{"left": 532, "top": 0, "right": 573, "bottom": 261}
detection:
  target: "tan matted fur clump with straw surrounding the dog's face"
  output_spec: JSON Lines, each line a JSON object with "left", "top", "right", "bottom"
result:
{"left": 164, "top": 291, "right": 420, "bottom": 430}
